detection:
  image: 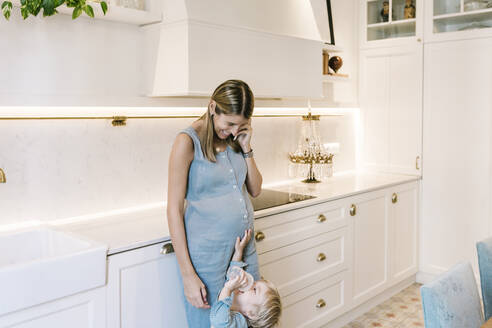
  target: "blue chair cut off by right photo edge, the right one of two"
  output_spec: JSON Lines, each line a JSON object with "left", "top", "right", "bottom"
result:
{"left": 477, "top": 238, "right": 492, "bottom": 321}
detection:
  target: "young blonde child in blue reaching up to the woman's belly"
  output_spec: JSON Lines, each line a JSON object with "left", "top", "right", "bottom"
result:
{"left": 210, "top": 229, "right": 282, "bottom": 328}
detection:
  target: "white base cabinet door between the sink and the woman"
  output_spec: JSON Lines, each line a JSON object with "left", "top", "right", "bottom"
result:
{"left": 107, "top": 242, "right": 187, "bottom": 328}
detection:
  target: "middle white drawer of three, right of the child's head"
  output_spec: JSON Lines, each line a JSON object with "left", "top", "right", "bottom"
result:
{"left": 258, "top": 227, "right": 349, "bottom": 296}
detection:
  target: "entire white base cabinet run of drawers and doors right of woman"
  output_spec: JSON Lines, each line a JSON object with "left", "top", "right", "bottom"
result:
{"left": 255, "top": 181, "right": 419, "bottom": 328}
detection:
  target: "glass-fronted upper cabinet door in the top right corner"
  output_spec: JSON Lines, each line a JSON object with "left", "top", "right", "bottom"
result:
{"left": 425, "top": 0, "right": 492, "bottom": 42}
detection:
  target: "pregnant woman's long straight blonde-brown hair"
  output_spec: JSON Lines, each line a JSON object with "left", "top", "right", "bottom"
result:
{"left": 198, "top": 80, "right": 255, "bottom": 162}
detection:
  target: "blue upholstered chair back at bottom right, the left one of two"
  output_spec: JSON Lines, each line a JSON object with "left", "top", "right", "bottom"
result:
{"left": 420, "top": 262, "right": 483, "bottom": 328}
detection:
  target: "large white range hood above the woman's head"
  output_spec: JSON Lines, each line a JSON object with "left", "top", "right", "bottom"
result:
{"left": 142, "top": 0, "right": 328, "bottom": 97}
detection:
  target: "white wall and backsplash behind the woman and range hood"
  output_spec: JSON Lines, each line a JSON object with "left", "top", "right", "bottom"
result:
{"left": 0, "top": 0, "right": 357, "bottom": 225}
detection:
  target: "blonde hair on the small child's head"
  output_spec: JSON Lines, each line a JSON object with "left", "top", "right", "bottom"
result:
{"left": 246, "top": 279, "right": 282, "bottom": 328}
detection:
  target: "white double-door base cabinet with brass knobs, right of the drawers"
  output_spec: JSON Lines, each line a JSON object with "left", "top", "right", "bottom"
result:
{"left": 349, "top": 182, "right": 418, "bottom": 304}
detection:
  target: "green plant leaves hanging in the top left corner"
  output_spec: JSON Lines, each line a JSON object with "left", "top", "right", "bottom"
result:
{"left": 1, "top": 0, "right": 108, "bottom": 20}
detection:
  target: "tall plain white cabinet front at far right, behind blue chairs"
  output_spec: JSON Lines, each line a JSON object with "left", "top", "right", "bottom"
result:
{"left": 421, "top": 38, "right": 492, "bottom": 278}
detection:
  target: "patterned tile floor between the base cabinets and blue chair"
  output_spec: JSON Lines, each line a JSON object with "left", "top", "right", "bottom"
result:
{"left": 343, "top": 283, "right": 424, "bottom": 328}
